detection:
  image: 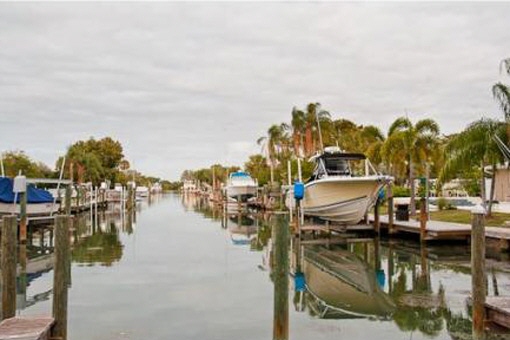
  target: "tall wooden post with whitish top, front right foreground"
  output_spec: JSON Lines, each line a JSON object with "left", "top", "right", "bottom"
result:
{"left": 471, "top": 207, "right": 485, "bottom": 340}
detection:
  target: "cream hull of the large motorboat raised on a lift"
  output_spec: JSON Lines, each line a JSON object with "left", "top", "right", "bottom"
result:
{"left": 302, "top": 176, "right": 385, "bottom": 224}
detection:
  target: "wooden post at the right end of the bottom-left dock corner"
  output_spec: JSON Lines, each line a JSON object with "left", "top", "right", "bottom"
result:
{"left": 53, "top": 215, "right": 71, "bottom": 340}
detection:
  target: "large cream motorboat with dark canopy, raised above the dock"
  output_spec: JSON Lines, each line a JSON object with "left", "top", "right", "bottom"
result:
{"left": 302, "top": 147, "right": 391, "bottom": 224}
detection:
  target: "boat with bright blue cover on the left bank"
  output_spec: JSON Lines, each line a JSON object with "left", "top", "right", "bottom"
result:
{"left": 0, "top": 177, "right": 58, "bottom": 216}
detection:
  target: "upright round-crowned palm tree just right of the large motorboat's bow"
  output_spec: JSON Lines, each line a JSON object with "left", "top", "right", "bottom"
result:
{"left": 383, "top": 117, "right": 439, "bottom": 216}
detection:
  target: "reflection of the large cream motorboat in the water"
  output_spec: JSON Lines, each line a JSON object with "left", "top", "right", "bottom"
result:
{"left": 304, "top": 246, "right": 396, "bottom": 319}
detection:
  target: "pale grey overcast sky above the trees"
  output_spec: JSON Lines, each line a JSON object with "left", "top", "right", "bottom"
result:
{"left": 0, "top": 3, "right": 510, "bottom": 180}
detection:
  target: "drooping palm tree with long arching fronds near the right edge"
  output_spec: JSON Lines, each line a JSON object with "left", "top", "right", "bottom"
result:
{"left": 439, "top": 118, "right": 506, "bottom": 216}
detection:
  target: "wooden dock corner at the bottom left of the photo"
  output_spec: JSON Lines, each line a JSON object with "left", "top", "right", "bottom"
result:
{"left": 0, "top": 316, "right": 55, "bottom": 340}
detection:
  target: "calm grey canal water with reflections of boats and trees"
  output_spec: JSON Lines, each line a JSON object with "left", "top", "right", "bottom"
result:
{"left": 18, "top": 195, "right": 510, "bottom": 340}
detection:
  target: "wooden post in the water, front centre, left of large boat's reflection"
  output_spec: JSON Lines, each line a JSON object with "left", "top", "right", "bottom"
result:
{"left": 273, "top": 215, "right": 289, "bottom": 340}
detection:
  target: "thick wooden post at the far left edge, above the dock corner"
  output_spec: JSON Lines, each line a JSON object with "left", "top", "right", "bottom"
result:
{"left": 2, "top": 216, "right": 18, "bottom": 319}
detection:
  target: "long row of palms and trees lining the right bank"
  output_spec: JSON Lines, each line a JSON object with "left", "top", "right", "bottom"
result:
{"left": 185, "top": 58, "right": 510, "bottom": 215}
